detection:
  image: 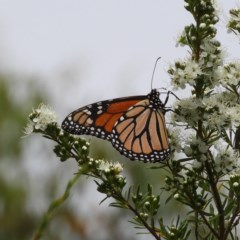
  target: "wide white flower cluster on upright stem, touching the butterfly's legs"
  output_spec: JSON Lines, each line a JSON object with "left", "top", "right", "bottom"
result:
{"left": 172, "top": 93, "right": 240, "bottom": 130}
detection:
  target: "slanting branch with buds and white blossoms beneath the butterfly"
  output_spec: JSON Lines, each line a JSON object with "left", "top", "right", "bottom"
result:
{"left": 25, "top": 104, "right": 189, "bottom": 240}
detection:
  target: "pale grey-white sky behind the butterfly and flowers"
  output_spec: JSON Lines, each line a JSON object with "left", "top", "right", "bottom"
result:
{"left": 0, "top": 0, "right": 240, "bottom": 239}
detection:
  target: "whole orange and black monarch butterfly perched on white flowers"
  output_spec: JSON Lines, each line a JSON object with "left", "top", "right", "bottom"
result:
{"left": 62, "top": 89, "right": 172, "bottom": 162}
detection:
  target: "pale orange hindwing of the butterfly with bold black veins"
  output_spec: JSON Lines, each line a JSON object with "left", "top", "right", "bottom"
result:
{"left": 112, "top": 94, "right": 171, "bottom": 162}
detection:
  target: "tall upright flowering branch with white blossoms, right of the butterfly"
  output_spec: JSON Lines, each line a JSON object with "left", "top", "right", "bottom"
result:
{"left": 169, "top": 0, "right": 239, "bottom": 240}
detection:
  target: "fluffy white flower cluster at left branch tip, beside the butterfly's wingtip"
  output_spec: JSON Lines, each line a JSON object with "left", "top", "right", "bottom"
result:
{"left": 24, "top": 104, "right": 57, "bottom": 135}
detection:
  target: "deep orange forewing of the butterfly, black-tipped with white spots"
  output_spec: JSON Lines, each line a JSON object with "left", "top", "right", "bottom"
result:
{"left": 62, "top": 96, "right": 144, "bottom": 140}
